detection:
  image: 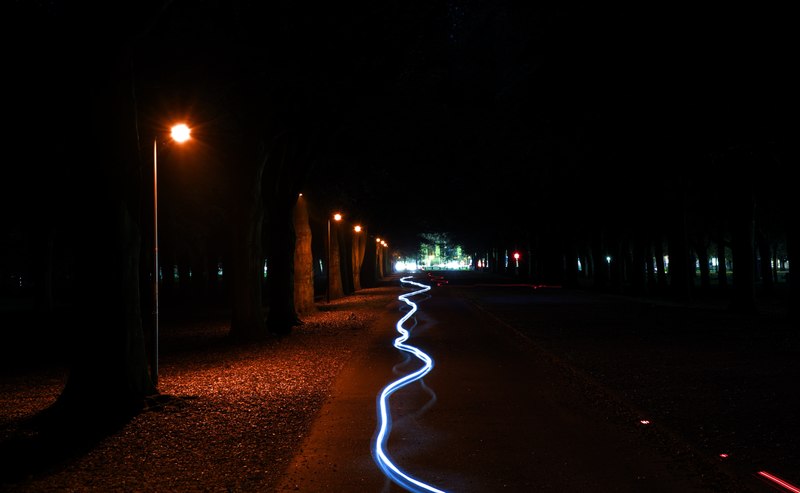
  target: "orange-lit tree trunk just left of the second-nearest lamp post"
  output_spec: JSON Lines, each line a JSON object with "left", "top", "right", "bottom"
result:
{"left": 294, "top": 197, "right": 317, "bottom": 316}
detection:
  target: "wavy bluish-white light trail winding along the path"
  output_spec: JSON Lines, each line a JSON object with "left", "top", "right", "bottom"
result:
{"left": 373, "top": 276, "right": 445, "bottom": 493}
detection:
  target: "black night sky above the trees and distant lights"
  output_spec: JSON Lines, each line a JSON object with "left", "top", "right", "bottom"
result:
{"left": 3, "top": 1, "right": 793, "bottom": 258}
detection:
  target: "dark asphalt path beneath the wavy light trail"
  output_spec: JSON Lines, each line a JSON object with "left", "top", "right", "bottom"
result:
{"left": 278, "top": 276, "right": 792, "bottom": 493}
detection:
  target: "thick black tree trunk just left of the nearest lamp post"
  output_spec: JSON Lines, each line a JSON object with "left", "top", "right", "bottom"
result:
{"left": 51, "top": 52, "right": 157, "bottom": 422}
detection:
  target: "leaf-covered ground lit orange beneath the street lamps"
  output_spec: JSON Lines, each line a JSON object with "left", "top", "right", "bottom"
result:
{"left": 0, "top": 287, "right": 398, "bottom": 492}
